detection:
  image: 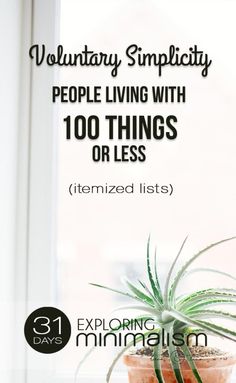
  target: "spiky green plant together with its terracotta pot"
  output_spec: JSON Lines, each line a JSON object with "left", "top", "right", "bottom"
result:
{"left": 77, "top": 237, "right": 236, "bottom": 383}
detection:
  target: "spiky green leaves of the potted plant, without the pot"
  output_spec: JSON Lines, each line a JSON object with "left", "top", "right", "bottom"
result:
{"left": 77, "top": 237, "right": 236, "bottom": 383}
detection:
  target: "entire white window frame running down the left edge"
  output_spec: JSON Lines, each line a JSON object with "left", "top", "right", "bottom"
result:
{"left": 0, "top": 0, "right": 60, "bottom": 383}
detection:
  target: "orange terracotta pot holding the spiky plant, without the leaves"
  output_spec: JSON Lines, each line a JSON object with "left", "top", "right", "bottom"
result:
{"left": 123, "top": 355, "right": 236, "bottom": 383}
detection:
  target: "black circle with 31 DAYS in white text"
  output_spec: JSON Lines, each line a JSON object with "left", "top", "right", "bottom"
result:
{"left": 24, "top": 307, "right": 71, "bottom": 354}
